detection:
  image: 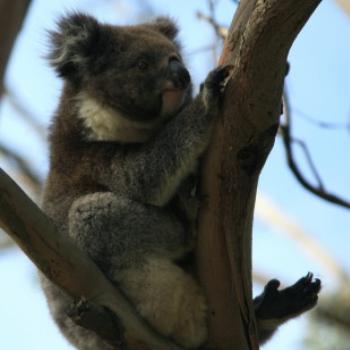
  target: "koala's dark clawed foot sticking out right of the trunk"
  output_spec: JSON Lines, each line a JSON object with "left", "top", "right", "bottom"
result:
{"left": 254, "top": 273, "right": 321, "bottom": 342}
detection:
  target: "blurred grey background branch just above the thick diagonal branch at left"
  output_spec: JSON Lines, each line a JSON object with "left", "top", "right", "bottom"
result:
{"left": 0, "top": 143, "right": 42, "bottom": 196}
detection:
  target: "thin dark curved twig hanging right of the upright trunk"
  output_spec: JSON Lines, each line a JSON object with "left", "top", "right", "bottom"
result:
{"left": 280, "top": 89, "right": 350, "bottom": 209}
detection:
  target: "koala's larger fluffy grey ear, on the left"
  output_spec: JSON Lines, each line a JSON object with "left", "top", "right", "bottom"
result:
{"left": 48, "top": 13, "right": 108, "bottom": 81}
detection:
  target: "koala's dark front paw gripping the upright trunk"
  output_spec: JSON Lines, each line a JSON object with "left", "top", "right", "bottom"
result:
{"left": 201, "top": 65, "right": 233, "bottom": 109}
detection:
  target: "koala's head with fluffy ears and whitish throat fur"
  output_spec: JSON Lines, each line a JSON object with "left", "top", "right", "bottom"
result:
{"left": 49, "top": 13, "right": 191, "bottom": 142}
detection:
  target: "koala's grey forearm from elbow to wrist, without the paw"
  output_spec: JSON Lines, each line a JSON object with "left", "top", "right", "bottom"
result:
{"left": 121, "top": 96, "right": 211, "bottom": 206}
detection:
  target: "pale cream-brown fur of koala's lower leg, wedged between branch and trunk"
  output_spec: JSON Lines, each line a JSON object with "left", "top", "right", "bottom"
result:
{"left": 118, "top": 257, "right": 207, "bottom": 348}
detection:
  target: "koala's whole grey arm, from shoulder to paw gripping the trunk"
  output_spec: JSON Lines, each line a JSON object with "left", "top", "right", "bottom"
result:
{"left": 83, "top": 66, "right": 231, "bottom": 206}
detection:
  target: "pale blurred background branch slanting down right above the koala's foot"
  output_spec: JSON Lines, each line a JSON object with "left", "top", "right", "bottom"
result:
{"left": 255, "top": 193, "right": 349, "bottom": 285}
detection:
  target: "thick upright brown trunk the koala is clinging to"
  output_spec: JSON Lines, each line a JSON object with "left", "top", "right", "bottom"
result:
{"left": 197, "top": 0, "right": 320, "bottom": 350}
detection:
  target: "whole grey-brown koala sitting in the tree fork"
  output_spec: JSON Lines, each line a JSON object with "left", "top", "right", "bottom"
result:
{"left": 42, "top": 13, "right": 320, "bottom": 350}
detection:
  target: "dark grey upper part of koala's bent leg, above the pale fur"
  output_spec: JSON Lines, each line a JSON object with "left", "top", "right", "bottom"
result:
{"left": 69, "top": 192, "right": 188, "bottom": 270}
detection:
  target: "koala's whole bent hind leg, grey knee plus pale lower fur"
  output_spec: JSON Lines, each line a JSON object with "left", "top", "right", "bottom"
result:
{"left": 69, "top": 193, "right": 207, "bottom": 348}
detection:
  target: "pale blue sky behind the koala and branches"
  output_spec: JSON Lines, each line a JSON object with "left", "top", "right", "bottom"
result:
{"left": 0, "top": 0, "right": 350, "bottom": 350}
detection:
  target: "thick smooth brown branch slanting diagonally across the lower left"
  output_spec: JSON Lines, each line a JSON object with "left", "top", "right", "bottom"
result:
{"left": 0, "top": 168, "right": 181, "bottom": 350}
